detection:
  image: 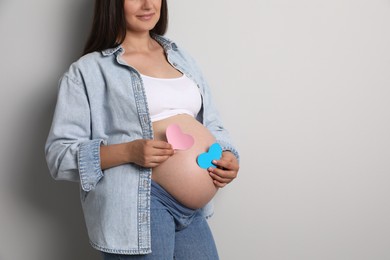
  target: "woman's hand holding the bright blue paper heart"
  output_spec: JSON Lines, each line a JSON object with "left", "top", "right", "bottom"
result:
{"left": 208, "top": 151, "right": 240, "bottom": 188}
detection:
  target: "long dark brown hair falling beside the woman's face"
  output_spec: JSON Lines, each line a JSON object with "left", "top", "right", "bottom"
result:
{"left": 84, "top": 0, "right": 168, "bottom": 54}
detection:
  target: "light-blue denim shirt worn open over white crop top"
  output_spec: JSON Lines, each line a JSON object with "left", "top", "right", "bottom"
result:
{"left": 45, "top": 35, "right": 239, "bottom": 254}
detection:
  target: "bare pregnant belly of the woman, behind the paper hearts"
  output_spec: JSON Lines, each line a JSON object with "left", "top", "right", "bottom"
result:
{"left": 152, "top": 115, "right": 218, "bottom": 209}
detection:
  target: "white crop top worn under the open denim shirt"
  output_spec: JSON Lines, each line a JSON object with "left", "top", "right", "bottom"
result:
{"left": 141, "top": 74, "right": 202, "bottom": 122}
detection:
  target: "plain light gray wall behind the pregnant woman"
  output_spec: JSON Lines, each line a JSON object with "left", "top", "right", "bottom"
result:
{"left": 0, "top": 0, "right": 390, "bottom": 260}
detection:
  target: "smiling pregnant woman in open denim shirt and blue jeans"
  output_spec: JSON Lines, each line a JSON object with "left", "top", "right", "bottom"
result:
{"left": 45, "top": 0, "right": 239, "bottom": 260}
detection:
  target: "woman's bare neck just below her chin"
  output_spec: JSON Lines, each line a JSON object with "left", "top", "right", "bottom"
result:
{"left": 122, "top": 32, "right": 155, "bottom": 52}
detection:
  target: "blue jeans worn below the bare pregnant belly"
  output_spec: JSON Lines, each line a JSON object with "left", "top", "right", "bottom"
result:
{"left": 103, "top": 181, "right": 219, "bottom": 260}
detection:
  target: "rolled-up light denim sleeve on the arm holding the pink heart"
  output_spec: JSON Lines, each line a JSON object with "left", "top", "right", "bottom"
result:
{"left": 45, "top": 74, "right": 106, "bottom": 191}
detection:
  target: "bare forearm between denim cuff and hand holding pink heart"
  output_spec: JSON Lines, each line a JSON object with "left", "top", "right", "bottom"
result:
{"left": 100, "top": 143, "right": 131, "bottom": 170}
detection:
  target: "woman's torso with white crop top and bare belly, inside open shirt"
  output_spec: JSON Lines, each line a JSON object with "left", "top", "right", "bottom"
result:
{"left": 122, "top": 39, "right": 217, "bottom": 208}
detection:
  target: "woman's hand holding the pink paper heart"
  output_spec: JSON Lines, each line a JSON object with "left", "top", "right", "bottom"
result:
{"left": 128, "top": 139, "right": 174, "bottom": 168}
